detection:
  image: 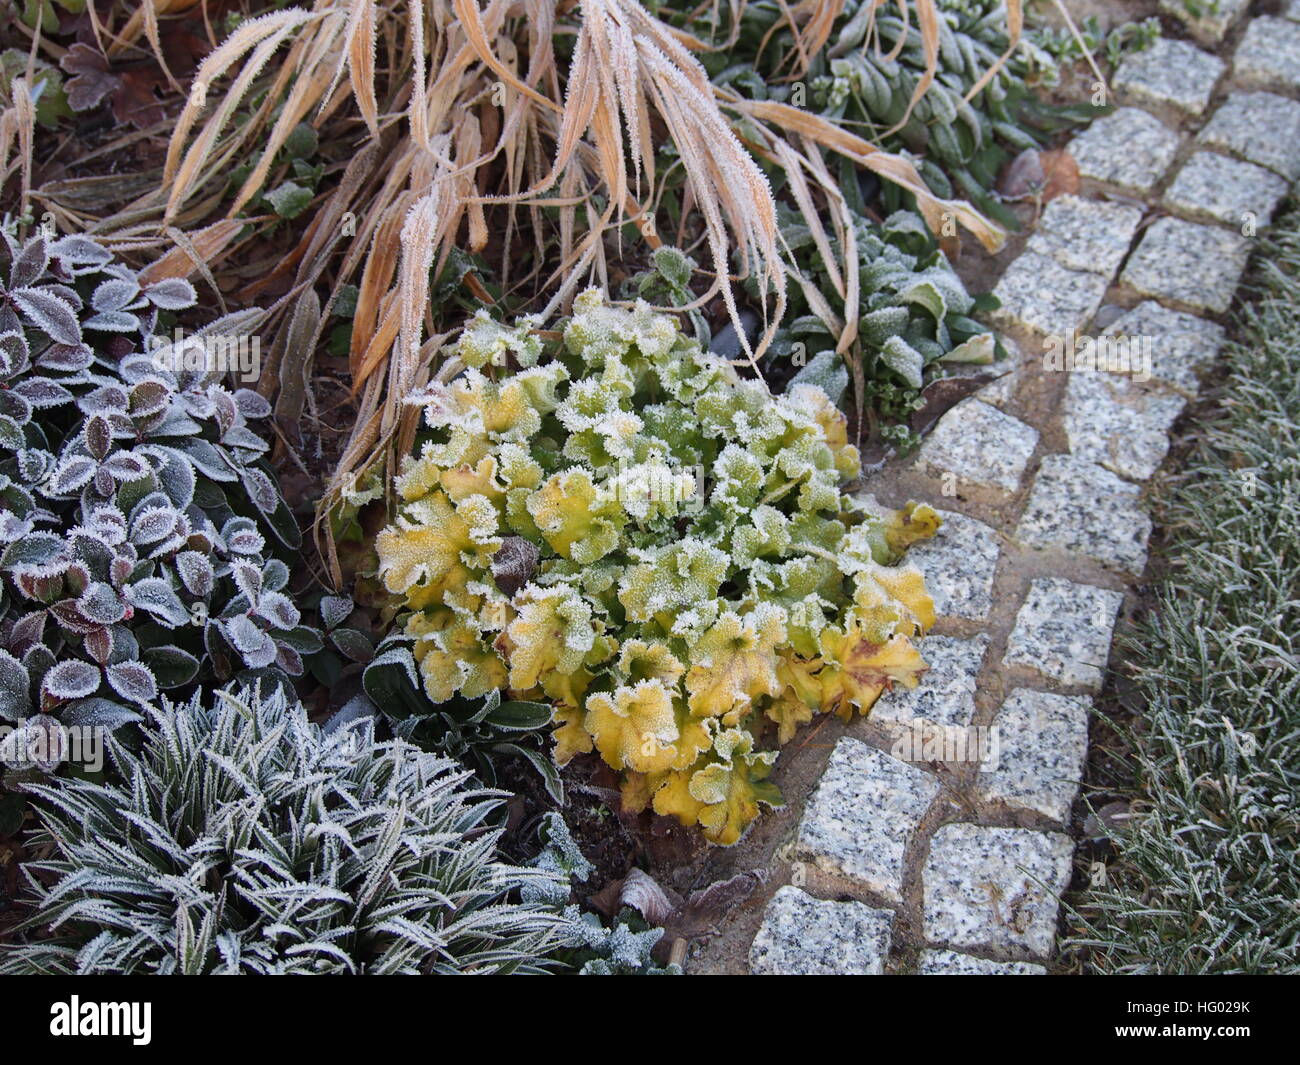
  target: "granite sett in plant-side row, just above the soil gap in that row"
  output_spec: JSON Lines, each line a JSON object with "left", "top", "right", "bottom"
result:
{"left": 991, "top": 250, "right": 1106, "bottom": 337}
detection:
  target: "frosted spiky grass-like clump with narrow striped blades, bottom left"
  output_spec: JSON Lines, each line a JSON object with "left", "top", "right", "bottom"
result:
{"left": 0, "top": 688, "right": 573, "bottom": 974}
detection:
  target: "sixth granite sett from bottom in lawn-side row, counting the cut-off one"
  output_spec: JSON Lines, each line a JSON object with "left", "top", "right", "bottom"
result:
{"left": 1061, "top": 371, "right": 1187, "bottom": 481}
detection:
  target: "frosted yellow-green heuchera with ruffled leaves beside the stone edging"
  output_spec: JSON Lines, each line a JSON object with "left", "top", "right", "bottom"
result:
{"left": 377, "top": 290, "right": 939, "bottom": 844}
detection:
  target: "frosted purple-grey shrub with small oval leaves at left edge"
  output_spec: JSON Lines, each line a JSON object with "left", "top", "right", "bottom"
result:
{"left": 0, "top": 226, "right": 321, "bottom": 769}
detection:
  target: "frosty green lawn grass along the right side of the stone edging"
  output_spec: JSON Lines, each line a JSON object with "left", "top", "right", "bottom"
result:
{"left": 1073, "top": 209, "right": 1300, "bottom": 974}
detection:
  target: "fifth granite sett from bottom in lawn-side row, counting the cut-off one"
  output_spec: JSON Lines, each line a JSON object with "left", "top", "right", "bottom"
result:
{"left": 1015, "top": 455, "right": 1152, "bottom": 576}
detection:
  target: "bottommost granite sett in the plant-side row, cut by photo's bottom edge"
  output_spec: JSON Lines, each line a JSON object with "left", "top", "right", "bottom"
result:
{"left": 749, "top": 884, "right": 893, "bottom": 977}
